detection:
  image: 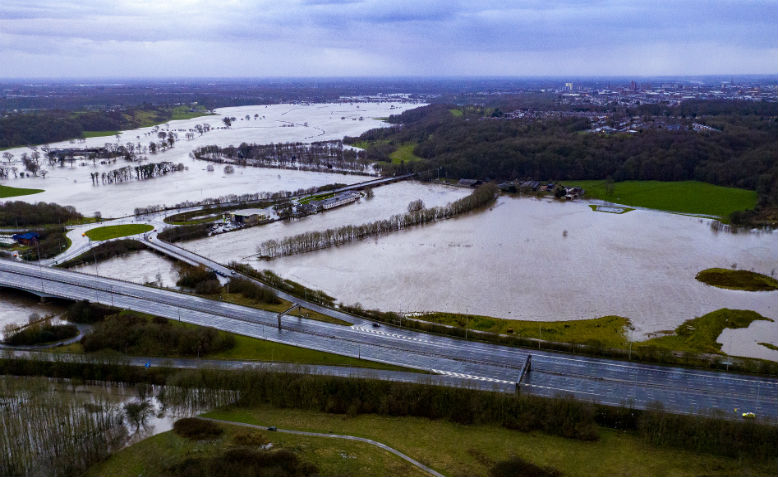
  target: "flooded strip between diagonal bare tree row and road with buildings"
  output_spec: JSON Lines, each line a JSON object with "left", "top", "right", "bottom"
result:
{"left": 185, "top": 181, "right": 470, "bottom": 263}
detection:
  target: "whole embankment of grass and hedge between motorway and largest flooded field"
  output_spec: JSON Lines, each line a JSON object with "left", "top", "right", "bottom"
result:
{"left": 354, "top": 305, "right": 778, "bottom": 376}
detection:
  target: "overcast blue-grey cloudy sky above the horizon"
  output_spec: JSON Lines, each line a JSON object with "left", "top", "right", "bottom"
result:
{"left": 0, "top": 0, "right": 778, "bottom": 78}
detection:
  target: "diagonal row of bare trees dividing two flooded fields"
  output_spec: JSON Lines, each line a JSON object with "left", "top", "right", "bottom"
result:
{"left": 257, "top": 184, "right": 498, "bottom": 258}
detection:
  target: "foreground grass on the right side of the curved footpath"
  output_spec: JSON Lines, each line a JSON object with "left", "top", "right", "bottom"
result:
{"left": 199, "top": 406, "right": 775, "bottom": 476}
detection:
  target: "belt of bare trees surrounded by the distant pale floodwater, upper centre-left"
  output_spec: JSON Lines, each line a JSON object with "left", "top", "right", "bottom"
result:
{"left": 194, "top": 141, "right": 370, "bottom": 172}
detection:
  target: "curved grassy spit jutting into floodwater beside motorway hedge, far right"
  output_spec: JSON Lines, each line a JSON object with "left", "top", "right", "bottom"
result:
{"left": 640, "top": 308, "right": 773, "bottom": 353}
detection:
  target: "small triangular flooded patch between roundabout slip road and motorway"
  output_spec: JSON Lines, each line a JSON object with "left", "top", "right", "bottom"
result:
{"left": 71, "top": 250, "right": 178, "bottom": 288}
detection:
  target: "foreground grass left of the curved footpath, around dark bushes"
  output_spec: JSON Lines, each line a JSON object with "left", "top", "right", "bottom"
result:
{"left": 86, "top": 416, "right": 425, "bottom": 477}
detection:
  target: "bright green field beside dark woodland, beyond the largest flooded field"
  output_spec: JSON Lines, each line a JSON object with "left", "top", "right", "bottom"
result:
{"left": 564, "top": 180, "right": 757, "bottom": 219}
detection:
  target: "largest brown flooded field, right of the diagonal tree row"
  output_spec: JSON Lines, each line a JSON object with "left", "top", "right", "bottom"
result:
{"left": 252, "top": 197, "right": 778, "bottom": 359}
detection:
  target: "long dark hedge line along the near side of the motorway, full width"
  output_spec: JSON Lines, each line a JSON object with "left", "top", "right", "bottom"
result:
{"left": 0, "top": 358, "right": 778, "bottom": 460}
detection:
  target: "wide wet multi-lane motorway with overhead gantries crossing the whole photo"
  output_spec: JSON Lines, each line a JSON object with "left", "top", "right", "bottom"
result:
{"left": 0, "top": 260, "right": 778, "bottom": 420}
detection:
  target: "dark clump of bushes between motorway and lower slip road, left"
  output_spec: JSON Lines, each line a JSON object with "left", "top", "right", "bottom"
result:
{"left": 81, "top": 310, "right": 235, "bottom": 356}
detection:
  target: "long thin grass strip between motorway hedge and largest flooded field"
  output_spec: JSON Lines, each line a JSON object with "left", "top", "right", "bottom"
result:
{"left": 419, "top": 313, "right": 632, "bottom": 347}
